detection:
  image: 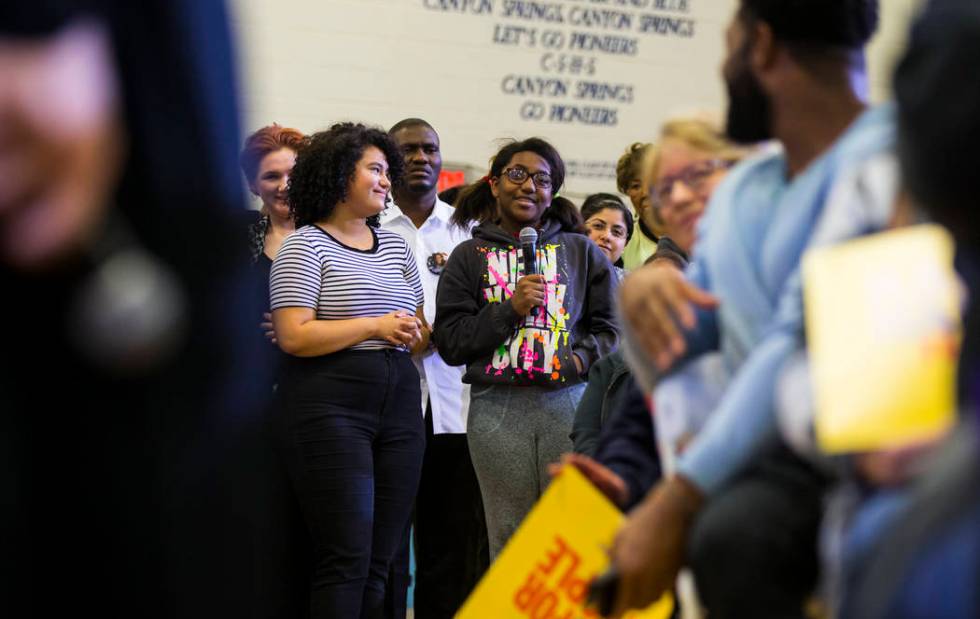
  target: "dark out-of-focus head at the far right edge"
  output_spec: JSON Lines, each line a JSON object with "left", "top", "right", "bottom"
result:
{"left": 894, "top": 0, "right": 980, "bottom": 416}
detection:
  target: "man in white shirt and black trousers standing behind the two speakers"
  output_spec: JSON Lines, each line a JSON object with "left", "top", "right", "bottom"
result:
{"left": 381, "top": 118, "right": 488, "bottom": 619}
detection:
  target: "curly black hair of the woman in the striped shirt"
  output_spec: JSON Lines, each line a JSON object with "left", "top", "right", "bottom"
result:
{"left": 286, "top": 123, "right": 405, "bottom": 228}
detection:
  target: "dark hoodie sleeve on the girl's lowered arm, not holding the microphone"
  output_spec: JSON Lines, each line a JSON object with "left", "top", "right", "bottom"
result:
{"left": 572, "top": 237, "right": 619, "bottom": 375}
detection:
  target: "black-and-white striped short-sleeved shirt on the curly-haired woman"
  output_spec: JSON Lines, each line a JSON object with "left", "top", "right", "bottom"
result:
{"left": 269, "top": 226, "right": 423, "bottom": 350}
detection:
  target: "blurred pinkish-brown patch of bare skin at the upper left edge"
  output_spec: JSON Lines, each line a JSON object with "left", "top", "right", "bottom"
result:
{"left": 0, "top": 18, "right": 124, "bottom": 269}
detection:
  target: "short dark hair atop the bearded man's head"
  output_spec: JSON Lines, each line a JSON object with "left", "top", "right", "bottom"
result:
{"left": 740, "top": 0, "right": 878, "bottom": 49}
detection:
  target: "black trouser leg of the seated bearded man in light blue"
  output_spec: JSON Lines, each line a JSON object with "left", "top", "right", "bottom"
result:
{"left": 688, "top": 446, "right": 827, "bottom": 619}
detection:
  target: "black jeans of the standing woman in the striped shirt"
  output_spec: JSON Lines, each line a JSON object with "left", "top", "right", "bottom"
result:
{"left": 277, "top": 350, "right": 425, "bottom": 619}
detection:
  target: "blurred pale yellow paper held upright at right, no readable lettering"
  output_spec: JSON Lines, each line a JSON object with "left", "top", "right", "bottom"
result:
{"left": 803, "top": 225, "right": 960, "bottom": 453}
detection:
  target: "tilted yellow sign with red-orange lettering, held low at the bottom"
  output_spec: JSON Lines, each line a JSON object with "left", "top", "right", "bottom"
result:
{"left": 456, "top": 466, "right": 673, "bottom": 619}
